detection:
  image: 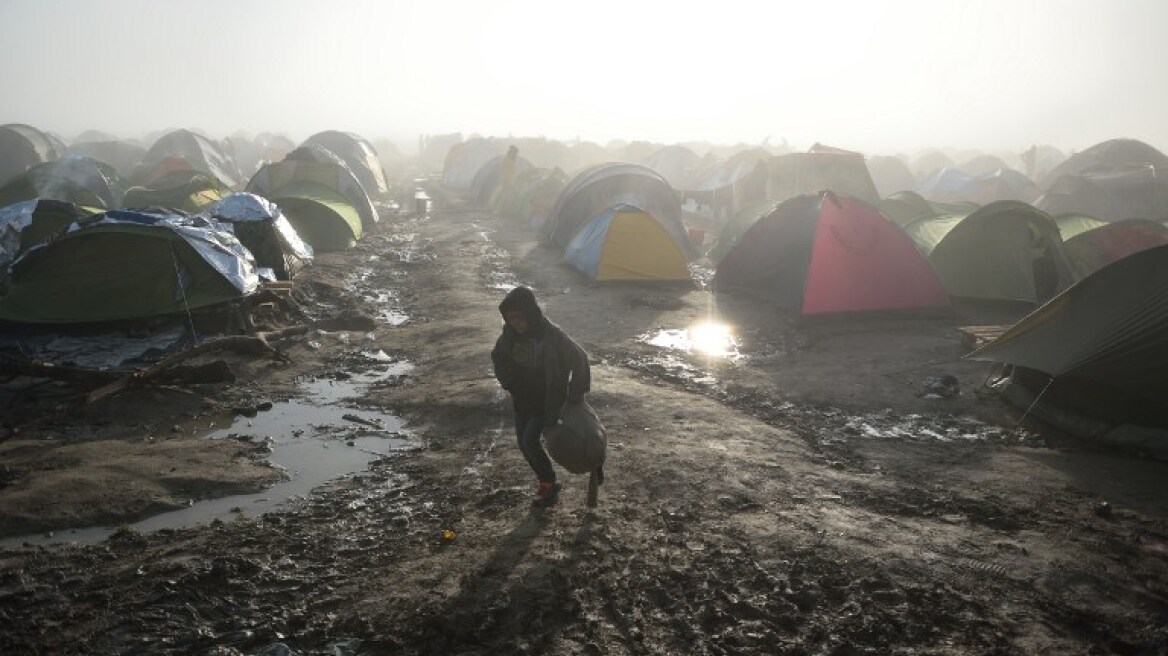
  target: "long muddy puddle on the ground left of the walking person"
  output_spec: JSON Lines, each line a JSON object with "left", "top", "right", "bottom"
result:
{"left": 0, "top": 362, "right": 418, "bottom": 549}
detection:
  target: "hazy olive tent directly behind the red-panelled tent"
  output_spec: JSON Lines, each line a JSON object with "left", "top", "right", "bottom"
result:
{"left": 766, "top": 144, "right": 880, "bottom": 204}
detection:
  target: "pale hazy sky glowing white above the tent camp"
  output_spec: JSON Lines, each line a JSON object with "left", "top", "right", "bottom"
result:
{"left": 0, "top": 0, "right": 1168, "bottom": 154}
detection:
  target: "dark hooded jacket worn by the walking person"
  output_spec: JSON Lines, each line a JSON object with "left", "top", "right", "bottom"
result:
{"left": 491, "top": 287, "right": 592, "bottom": 425}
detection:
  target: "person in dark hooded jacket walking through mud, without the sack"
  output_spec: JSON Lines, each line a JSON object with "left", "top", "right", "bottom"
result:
{"left": 491, "top": 286, "right": 591, "bottom": 507}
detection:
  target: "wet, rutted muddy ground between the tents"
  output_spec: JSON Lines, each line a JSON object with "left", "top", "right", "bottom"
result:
{"left": 0, "top": 191, "right": 1168, "bottom": 655}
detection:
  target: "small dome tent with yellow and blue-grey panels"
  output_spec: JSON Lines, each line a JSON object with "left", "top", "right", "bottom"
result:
{"left": 564, "top": 203, "right": 693, "bottom": 281}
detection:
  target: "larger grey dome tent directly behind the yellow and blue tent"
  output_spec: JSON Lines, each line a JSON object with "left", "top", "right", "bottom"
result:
{"left": 544, "top": 162, "right": 694, "bottom": 249}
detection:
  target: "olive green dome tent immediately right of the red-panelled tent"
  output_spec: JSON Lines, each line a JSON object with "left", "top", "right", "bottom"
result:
{"left": 904, "top": 201, "right": 1075, "bottom": 303}
